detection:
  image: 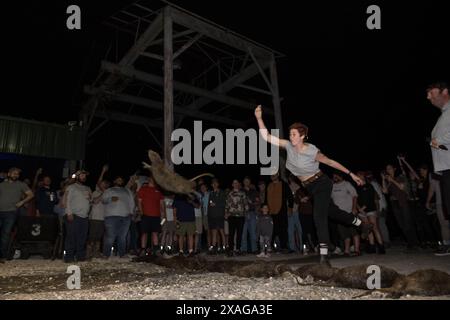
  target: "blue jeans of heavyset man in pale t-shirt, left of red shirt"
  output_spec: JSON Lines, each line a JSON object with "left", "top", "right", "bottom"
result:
{"left": 103, "top": 216, "right": 131, "bottom": 257}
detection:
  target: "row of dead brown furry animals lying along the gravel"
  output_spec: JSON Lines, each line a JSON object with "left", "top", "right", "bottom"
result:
{"left": 135, "top": 256, "right": 450, "bottom": 298}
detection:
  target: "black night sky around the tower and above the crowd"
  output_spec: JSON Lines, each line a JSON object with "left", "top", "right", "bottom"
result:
{"left": 0, "top": 0, "right": 450, "bottom": 184}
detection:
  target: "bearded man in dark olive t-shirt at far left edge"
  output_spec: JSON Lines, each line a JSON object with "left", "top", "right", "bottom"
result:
{"left": 0, "top": 168, "right": 34, "bottom": 263}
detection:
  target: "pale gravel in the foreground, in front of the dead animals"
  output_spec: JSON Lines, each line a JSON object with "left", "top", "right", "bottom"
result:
{"left": 0, "top": 252, "right": 450, "bottom": 300}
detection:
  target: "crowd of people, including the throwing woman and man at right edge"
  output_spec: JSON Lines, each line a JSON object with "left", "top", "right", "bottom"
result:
{"left": 0, "top": 83, "right": 450, "bottom": 264}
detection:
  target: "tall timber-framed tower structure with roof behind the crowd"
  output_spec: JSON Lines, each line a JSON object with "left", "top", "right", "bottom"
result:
{"left": 80, "top": 0, "right": 284, "bottom": 166}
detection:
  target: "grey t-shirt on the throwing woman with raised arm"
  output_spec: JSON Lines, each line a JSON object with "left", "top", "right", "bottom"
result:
{"left": 286, "top": 141, "right": 319, "bottom": 177}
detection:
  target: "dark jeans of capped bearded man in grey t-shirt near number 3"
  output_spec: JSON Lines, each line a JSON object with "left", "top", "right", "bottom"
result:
{"left": 64, "top": 215, "right": 89, "bottom": 261}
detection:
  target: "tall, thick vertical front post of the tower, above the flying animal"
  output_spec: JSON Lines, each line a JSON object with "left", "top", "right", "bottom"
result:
{"left": 163, "top": 6, "right": 174, "bottom": 169}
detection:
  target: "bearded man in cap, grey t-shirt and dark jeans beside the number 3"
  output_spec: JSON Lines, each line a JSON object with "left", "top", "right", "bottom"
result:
{"left": 64, "top": 170, "right": 92, "bottom": 263}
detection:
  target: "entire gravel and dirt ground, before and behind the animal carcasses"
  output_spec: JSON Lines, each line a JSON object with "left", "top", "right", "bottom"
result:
{"left": 0, "top": 245, "right": 450, "bottom": 300}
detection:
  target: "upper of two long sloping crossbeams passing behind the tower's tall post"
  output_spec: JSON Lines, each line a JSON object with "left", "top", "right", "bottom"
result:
{"left": 101, "top": 61, "right": 255, "bottom": 111}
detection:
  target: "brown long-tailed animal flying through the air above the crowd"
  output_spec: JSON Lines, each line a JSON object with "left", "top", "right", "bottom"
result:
{"left": 142, "top": 150, "right": 214, "bottom": 196}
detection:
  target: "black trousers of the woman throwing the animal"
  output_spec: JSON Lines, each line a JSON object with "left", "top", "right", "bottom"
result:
{"left": 306, "top": 175, "right": 355, "bottom": 244}
